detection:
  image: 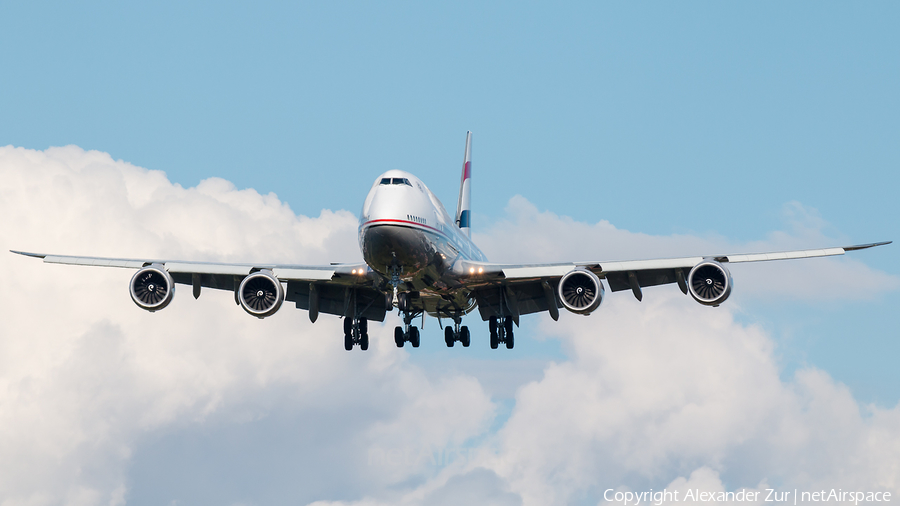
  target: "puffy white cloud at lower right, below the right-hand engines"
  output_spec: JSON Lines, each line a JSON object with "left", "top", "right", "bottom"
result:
{"left": 474, "top": 294, "right": 900, "bottom": 504}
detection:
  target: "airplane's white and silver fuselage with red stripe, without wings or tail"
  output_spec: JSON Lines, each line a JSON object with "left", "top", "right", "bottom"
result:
{"left": 359, "top": 170, "right": 486, "bottom": 292}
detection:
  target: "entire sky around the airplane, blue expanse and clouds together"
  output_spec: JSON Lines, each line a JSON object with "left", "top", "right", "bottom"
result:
{"left": 0, "top": 2, "right": 900, "bottom": 506}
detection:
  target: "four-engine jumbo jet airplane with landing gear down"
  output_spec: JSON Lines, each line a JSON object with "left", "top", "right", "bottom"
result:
{"left": 10, "top": 132, "right": 891, "bottom": 351}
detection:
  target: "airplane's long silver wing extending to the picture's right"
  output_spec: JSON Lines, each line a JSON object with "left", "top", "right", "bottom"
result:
{"left": 457, "top": 241, "right": 891, "bottom": 320}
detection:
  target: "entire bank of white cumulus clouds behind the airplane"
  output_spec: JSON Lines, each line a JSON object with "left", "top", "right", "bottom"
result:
{"left": 0, "top": 146, "right": 900, "bottom": 505}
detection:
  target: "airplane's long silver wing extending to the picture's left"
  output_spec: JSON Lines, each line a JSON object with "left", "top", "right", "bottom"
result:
{"left": 11, "top": 250, "right": 392, "bottom": 321}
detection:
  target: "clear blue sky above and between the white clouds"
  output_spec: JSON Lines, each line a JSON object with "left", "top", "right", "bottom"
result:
{"left": 0, "top": 2, "right": 900, "bottom": 502}
